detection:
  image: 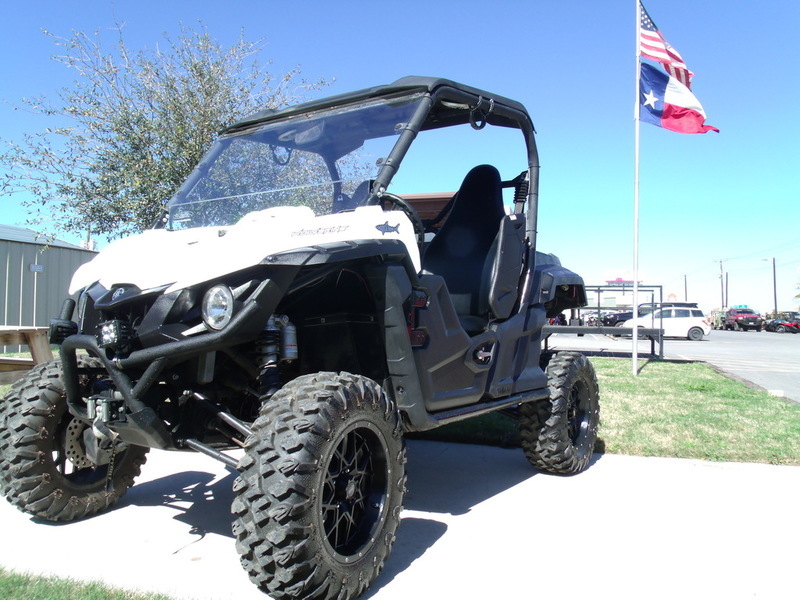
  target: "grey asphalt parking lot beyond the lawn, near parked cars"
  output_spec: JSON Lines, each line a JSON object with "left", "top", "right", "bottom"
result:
{"left": 549, "top": 331, "right": 800, "bottom": 402}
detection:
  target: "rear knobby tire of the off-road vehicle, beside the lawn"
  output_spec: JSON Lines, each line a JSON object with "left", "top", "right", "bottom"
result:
{"left": 520, "top": 352, "right": 600, "bottom": 475}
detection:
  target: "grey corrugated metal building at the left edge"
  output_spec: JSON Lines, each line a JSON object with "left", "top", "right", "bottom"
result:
{"left": 0, "top": 225, "right": 96, "bottom": 327}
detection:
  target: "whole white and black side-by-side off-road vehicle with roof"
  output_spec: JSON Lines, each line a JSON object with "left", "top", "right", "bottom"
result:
{"left": 0, "top": 77, "right": 599, "bottom": 599}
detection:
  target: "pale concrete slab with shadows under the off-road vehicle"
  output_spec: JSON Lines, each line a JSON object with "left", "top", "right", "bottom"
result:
{"left": 0, "top": 441, "right": 800, "bottom": 600}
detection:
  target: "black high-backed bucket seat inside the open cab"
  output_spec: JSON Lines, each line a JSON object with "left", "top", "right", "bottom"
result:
{"left": 422, "top": 165, "right": 505, "bottom": 335}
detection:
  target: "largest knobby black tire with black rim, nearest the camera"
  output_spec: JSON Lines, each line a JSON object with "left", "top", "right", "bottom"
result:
{"left": 233, "top": 372, "right": 406, "bottom": 600}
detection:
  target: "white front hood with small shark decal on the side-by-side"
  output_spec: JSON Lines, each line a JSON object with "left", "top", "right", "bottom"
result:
{"left": 69, "top": 206, "right": 420, "bottom": 294}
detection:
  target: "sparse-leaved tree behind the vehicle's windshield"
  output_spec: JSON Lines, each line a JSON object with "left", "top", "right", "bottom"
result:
{"left": 0, "top": 24, "right": 329, "bottom": 238}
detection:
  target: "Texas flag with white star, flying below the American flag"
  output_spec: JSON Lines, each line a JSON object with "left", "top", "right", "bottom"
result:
{"left": 639, "top": 63, "right": 719, "bottom": 133}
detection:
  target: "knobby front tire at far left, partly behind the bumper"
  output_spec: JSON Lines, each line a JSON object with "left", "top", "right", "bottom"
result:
{"left": 0, "top": 356, "right": 148, "bottom": 521}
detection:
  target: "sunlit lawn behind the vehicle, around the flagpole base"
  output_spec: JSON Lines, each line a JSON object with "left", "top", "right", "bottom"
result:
{"left": 412, "top": 358, "right": 800, "bottom": 465}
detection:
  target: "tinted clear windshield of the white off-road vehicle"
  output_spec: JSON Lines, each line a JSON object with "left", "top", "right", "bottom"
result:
{"left": 166, "top": 95, "right": 420, "bottom": 229}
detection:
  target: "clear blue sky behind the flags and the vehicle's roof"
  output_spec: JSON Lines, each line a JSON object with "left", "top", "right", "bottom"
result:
{"left": 0, "top": 0, "right": 800, "bottom": 312}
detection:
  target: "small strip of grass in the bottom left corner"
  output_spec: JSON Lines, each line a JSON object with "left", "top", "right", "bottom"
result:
{"left": 0, "top": 567, "right": 169, "bottom": 600}
